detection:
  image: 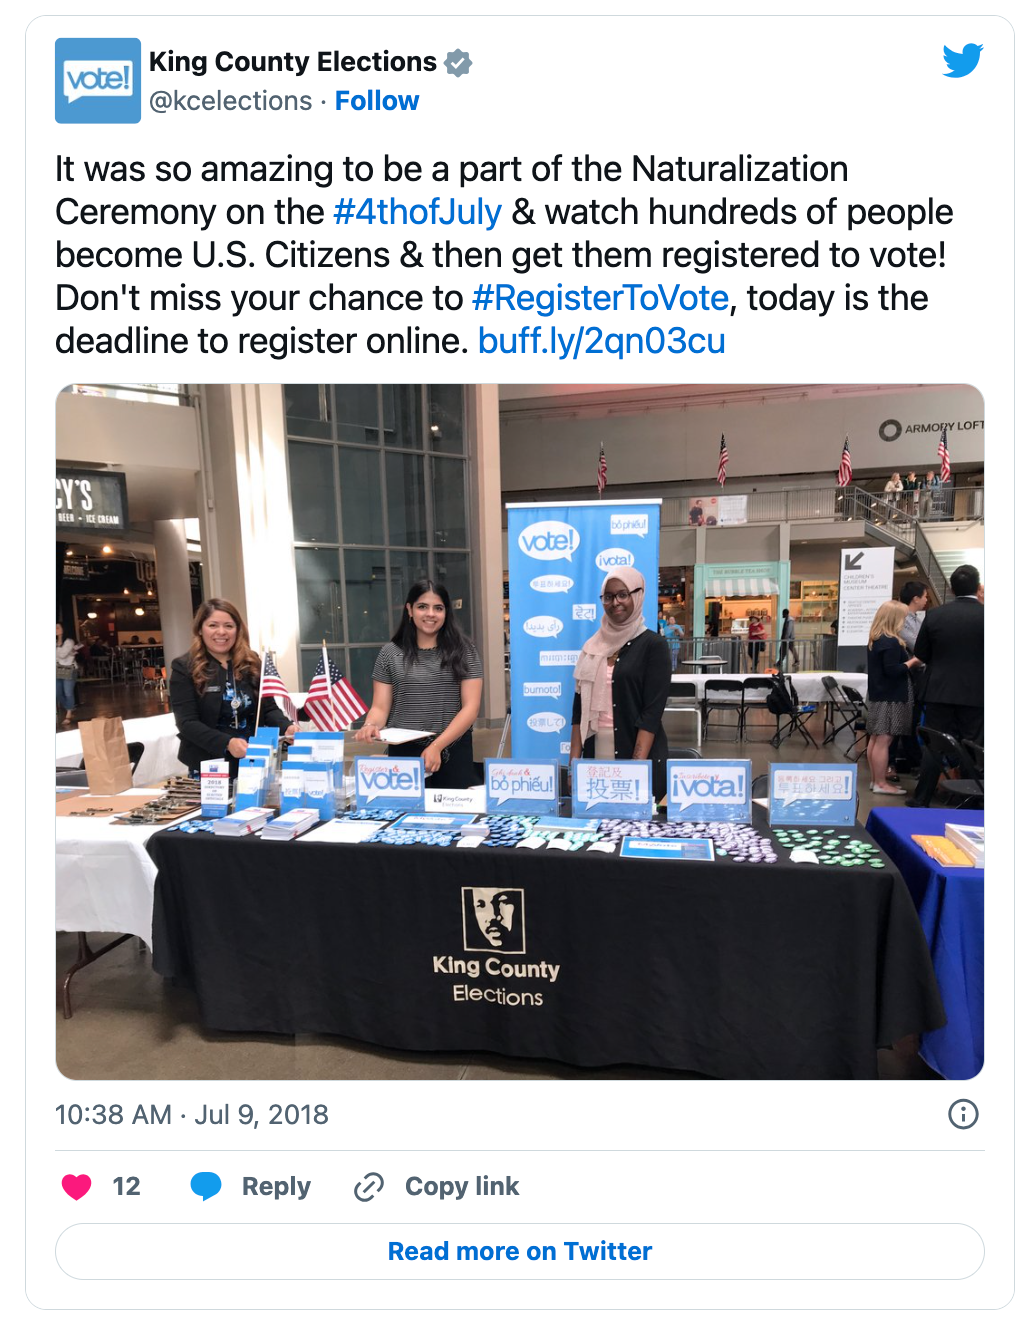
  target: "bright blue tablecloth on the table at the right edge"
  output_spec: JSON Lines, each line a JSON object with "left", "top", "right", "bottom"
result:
{"left": 867, "top": 806, "right": 985, "bottom": 1078}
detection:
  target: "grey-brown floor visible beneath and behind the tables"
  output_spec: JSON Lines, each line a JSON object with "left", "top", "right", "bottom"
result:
{"left": 57, "top": 686, "right": 936, "bottom": 1080}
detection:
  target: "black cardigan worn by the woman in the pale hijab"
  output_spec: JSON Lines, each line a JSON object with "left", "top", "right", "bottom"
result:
{"left": 573, "top": 629, "right": 670, "bottom": 801}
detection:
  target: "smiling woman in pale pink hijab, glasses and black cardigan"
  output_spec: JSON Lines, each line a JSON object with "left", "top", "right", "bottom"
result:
{"left": 570, "top": 569, "right": 670, "bottom": 801}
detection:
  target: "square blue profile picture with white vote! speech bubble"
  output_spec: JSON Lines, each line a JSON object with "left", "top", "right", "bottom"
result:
{"left": 53, "top": 37, "right": 141, "bottom": 125}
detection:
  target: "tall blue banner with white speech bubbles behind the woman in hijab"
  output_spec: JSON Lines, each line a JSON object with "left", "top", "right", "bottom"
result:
{"left": 507, "top": 500, "right": 662, "bottom": 763}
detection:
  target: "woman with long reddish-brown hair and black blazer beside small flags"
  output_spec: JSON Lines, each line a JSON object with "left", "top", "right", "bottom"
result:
{"left": 169, "top": 597, "right": 294, "bottom": 777}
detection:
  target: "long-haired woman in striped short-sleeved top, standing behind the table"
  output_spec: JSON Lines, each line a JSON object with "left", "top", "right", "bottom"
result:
{"left": 356, "top": 578, "right": 483, "bottom": 790}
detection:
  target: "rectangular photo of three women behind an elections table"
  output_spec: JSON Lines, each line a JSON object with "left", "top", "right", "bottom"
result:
{"left": 54, "top": 384, "right": 984, "bottom": 1080}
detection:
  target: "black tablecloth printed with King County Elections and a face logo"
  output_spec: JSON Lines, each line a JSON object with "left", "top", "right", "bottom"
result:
{"left": 148, "top": 830, "right": 944, "bottom": 1078}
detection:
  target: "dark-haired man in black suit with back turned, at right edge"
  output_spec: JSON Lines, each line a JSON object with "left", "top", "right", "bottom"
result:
{"left": 907, "top": 565, "right": 985, "bottom": 807}
